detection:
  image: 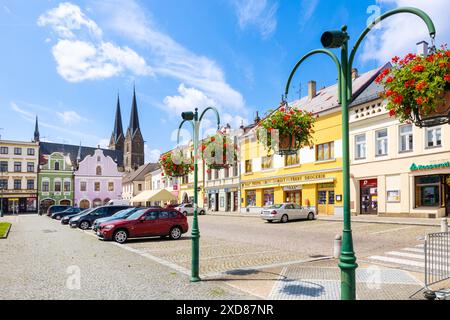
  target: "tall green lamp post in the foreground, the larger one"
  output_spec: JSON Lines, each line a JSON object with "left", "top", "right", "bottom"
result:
{"left": 284, "top": 7, "right": 436, "bottom": 300}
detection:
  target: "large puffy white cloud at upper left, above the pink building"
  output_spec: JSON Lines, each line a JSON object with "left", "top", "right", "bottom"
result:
{"left": 38, "top": 2, "right": 152, "bottom": 82}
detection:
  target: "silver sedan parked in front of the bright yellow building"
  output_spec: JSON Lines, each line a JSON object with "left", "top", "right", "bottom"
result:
{"left": 261, "top": 203, "right": 316, "bottom": 223}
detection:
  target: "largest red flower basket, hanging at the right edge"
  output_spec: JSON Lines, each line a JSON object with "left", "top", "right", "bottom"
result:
{"left": 376, "top": 46, "right": 450, "bottom": 128}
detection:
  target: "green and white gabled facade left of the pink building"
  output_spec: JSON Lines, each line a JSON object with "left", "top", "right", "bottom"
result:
{"left": 38, "top": 152, "right": 74, "bottom": 212}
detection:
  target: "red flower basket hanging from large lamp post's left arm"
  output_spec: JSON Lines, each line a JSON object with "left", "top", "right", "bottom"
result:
{"left": 257, "top": 101, "right": 315, "bottom": 155}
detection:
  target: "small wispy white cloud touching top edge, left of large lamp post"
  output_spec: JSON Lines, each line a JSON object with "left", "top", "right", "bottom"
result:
{"left": 232, "top": 0, "right": 278, "bottom": 38}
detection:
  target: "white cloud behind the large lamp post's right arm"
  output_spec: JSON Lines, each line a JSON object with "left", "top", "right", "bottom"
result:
{"left": 360, "top": 0, "right": 450, "bottom": 64}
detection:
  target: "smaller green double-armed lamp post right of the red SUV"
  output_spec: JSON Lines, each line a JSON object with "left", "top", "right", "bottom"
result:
{"left": 177, "top": 107, "right": 220, "bottom": 282}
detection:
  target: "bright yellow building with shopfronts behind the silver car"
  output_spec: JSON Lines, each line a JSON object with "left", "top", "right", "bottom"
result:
{"left": 240, "top": 70, "right": 375, "bottom": 215}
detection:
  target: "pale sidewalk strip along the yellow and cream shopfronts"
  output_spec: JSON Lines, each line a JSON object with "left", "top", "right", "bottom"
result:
{"left": 206, "top": 211, "right": 442, "bottom": 226}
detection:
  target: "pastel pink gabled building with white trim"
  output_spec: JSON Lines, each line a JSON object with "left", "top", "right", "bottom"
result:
{"left": 74, "top": 149, "right": 123, "bottom": 209}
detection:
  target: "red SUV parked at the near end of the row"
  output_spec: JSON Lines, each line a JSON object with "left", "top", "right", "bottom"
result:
{"left": 97, "top": 208, "right": 189, "bottom": 243}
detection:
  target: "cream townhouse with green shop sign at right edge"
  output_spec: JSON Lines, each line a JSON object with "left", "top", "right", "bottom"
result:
{"left": 350, "top": 65, "right": 450, "bottom": 218}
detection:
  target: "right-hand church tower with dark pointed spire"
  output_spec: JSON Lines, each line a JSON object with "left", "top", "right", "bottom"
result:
{"left": 124, "top": 88, "right": 144, "bottom": 172}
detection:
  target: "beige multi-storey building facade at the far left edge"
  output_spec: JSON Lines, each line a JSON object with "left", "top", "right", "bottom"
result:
{"left": 0, "top": 140, "right": 39, "bottom": 213}
